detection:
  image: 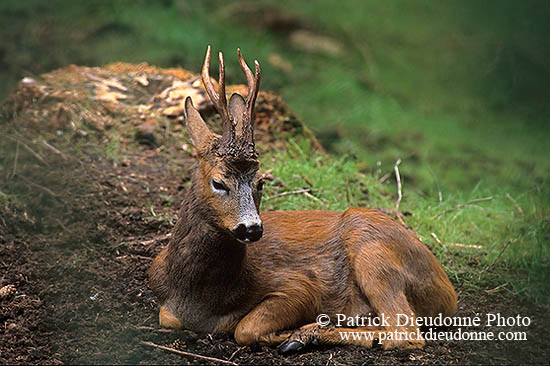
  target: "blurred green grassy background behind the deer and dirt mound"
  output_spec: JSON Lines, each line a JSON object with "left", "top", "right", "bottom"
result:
{"left": 0, "top": 0, "right": 550, "bottom": 301}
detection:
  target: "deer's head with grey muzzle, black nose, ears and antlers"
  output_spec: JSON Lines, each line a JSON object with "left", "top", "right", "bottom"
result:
{"left": 185, "top": 46, "right": 263, "bottom": 242}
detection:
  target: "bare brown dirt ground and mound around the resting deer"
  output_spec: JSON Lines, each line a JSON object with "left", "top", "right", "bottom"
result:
{"left": 0, "top": 64, "right": 550, "bottom": 365}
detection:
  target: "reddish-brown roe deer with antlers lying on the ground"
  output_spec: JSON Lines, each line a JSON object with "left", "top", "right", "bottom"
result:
{"left": 149, "top": 46, "right": 457, "bottom": 352}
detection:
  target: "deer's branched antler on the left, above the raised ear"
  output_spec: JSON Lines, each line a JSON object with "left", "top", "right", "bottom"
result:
{"left": 201, "top": 45, "right": 233, "bottom": 136}
